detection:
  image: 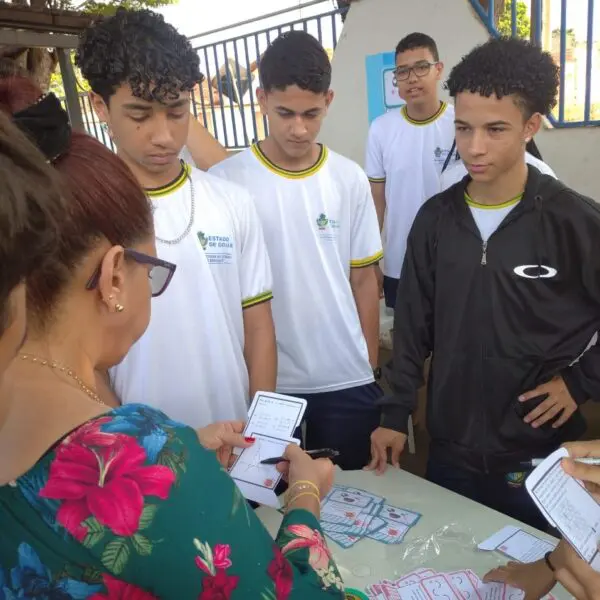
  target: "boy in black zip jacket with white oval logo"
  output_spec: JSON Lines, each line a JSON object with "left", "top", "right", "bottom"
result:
{"left": 372, "top": 39, "right": 600, "bottom": 528}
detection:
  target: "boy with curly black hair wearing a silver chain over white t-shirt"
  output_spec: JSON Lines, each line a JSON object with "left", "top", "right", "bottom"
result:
{"left": 76, "top": 9, "right": 276, "bottom": 428}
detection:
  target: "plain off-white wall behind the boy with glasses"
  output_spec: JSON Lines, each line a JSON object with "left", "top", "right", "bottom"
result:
{"left": 321, "top": 0, "right": 600, "bottom": 201}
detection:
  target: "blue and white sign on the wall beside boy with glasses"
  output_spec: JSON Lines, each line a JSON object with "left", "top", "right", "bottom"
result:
{"left": 365, "top": 52, "right": 404, "bottom": 123}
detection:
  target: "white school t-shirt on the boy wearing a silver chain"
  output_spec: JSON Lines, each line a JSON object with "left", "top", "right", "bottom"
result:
{"left": 110, "top": 164, "right": 272, "bottom": 428}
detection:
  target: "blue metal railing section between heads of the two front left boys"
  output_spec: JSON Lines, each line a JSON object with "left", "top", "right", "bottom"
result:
{"left": 189, "top": 0, "right": 347, "bottom": 150}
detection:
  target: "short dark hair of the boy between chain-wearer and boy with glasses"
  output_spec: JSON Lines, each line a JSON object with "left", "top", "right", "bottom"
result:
{"left": 259, "top": 31, "right": 331, "bottom": 94}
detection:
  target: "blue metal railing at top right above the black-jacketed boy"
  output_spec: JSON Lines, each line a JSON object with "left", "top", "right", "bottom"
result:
{"left": 470, "top": 0, "right": 600, "bottom": 128}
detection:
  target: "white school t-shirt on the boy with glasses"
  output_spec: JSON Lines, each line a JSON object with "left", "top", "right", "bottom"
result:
{"left": 365, "top": 102, "right": 455, "bottom": 279}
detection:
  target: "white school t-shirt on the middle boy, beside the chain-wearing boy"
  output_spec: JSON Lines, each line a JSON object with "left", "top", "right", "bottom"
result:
{"left": 210, "top": 145, "right": 382, "bottom": 394}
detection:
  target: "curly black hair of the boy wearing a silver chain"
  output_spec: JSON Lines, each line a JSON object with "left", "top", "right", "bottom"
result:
{"left": 75, "top": 8, "right": 202, "bottom": 104}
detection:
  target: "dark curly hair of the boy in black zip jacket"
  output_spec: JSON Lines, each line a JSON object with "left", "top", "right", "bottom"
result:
{"left": 446, "top": 38, "right": 559, "bottom": 119}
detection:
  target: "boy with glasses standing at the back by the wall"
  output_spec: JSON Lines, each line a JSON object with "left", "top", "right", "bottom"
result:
{"left": 365, "top": 33, "right": 454, "bottom": 308}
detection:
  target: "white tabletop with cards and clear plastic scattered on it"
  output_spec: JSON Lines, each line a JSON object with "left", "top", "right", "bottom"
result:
{"left": 257, "top": 468, "right": 571, "bottom": 600}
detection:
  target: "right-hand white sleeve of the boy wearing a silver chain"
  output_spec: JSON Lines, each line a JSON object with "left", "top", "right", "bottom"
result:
{"left": 238, "top": 194, "right": 273, "bottom": 308}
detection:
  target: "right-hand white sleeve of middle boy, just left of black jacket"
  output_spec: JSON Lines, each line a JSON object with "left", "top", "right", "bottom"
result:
{"left": 350, "top": 171, "right": 383, "bottom": 268}
